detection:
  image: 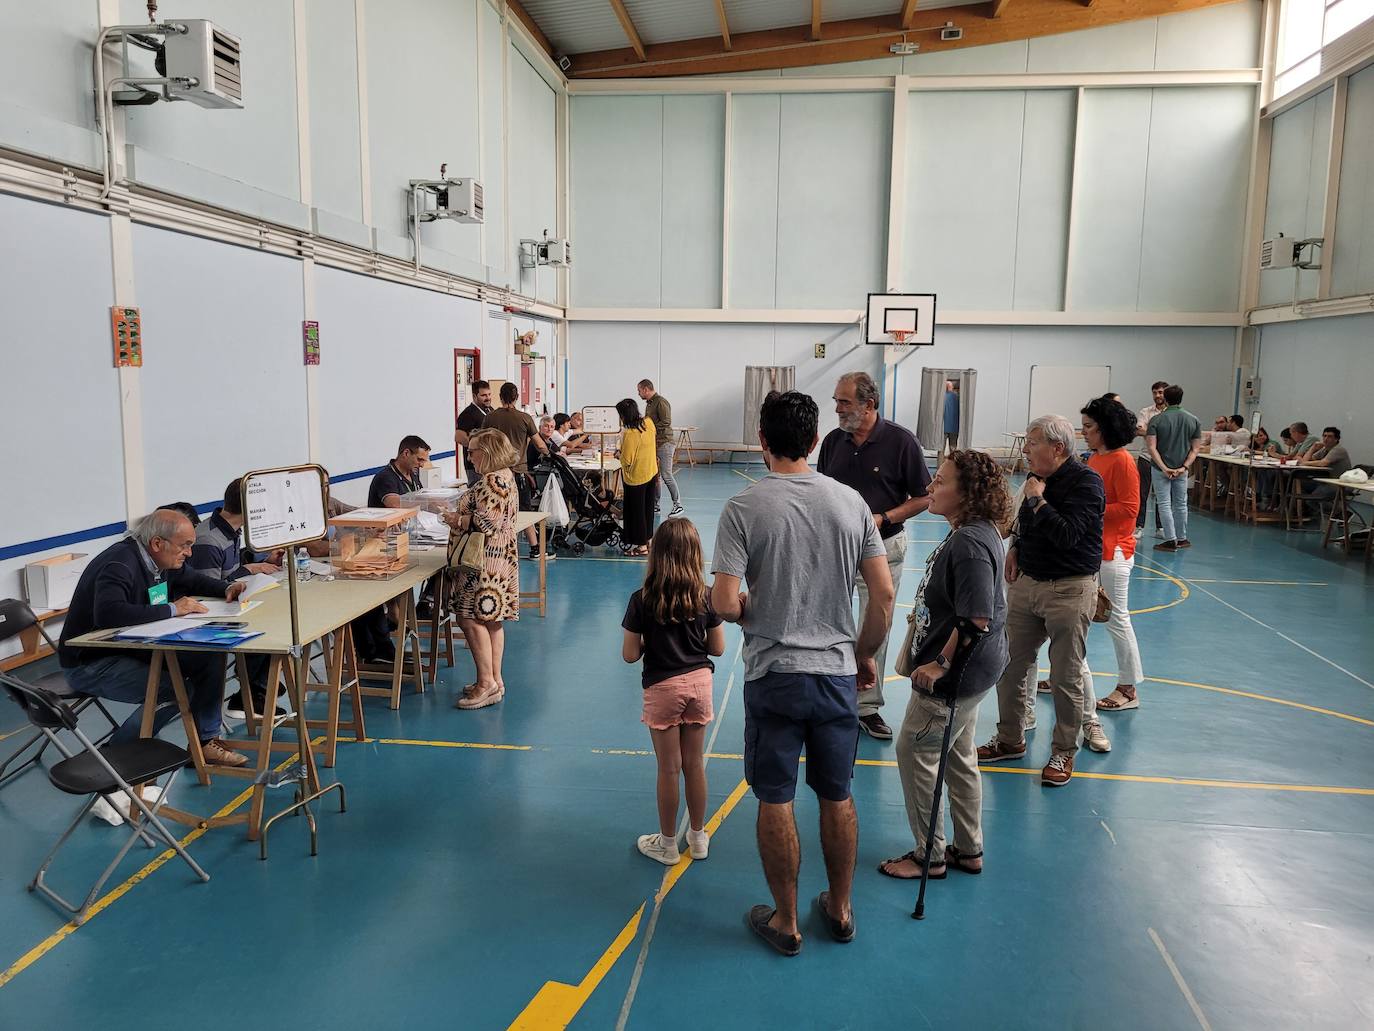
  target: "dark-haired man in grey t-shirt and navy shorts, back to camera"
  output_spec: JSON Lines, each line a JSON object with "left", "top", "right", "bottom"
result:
{"left": 712, "top": 390, "right": 893, "bottom": 955}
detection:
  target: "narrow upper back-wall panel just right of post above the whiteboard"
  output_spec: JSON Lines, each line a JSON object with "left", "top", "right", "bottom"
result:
{"left": 1069, "top": 89, "right": 1151, "bottom": 311}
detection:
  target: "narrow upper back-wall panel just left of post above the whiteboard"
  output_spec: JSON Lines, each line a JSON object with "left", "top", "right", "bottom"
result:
{"left": 1013, "top": 89, "right": 1077, "bottom": 311}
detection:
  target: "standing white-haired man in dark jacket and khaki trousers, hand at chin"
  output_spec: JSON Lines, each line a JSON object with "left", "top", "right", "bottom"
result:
{"left": 978, "top": 415, "right": 1106, "bottom": 788}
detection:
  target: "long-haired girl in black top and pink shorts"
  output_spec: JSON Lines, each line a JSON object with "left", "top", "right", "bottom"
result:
{"left": 621, "top": 518, "right": 725, "bottom": 866}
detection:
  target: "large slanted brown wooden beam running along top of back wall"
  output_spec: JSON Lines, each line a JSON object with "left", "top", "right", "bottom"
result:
{"left": 570, "top": 0, "right": 1237, "bottom": 78}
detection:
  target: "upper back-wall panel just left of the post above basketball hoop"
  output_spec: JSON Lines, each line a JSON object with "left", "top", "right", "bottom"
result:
{"left": 774, "top": 93, "right": 892, "bottom": 308}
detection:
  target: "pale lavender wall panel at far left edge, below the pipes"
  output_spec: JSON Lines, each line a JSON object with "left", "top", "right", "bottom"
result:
{"left": 0, "top": 194, "right": 122, "bottom": 549}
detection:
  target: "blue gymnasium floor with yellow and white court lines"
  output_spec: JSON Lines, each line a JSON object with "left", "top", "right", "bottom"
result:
{"left": 0, "top": 466, "right": 1374, "bottom": 1031}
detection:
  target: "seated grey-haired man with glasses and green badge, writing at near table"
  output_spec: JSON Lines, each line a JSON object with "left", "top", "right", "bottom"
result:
{"left": 58, "top": 509, "right": 249, "bottom": 766}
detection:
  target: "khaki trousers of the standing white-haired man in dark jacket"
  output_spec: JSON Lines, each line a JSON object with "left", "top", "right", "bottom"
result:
{"left": 998, "top": 573, "right": 1098, "bottom": 755}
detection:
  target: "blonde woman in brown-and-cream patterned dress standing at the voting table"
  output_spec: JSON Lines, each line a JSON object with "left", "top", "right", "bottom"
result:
{"left": 447, "top": 429, "right": 519, "bottom": 709}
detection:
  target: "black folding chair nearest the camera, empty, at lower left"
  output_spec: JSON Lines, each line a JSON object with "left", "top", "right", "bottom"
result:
{"left": 0, "top": 674, "right": 210, "bottom": 924}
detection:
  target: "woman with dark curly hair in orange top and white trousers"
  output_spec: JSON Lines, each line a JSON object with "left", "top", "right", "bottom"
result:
{"left": 1083, "top": 395, "right": 1142, "bottom": 720}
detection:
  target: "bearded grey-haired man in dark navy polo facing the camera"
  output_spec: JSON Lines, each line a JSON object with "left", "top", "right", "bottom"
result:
{"left": 816, "top": 373, "right": 930, "bottom": 741}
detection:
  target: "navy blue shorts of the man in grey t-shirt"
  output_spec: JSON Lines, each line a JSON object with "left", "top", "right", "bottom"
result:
{"left": 745, "top": 672, "right": 859, "bottom": 806}
